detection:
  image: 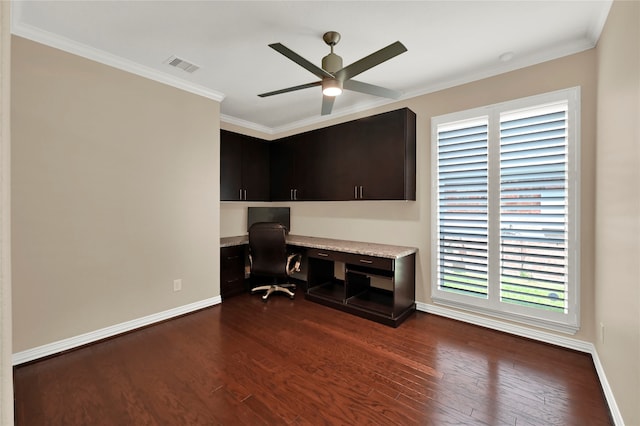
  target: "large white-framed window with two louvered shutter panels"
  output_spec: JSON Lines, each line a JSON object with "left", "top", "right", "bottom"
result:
{"left": 432, "top": 88, "right": 580, "bottom": 333}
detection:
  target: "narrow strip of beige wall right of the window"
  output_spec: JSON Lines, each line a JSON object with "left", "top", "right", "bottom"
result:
{"left": 595, "top": 1, "right": 640, "bottom": 425}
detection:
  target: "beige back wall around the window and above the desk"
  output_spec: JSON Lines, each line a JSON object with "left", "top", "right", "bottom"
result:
{"left": 220, "top": 49, "right": 596, "bottom": 341}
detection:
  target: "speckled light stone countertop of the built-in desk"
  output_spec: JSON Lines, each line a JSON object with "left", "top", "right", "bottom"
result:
{"left": 220, "top": 234, "right": 418, "bottom": 259}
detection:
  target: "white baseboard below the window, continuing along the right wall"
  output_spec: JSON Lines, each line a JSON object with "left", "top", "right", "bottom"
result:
{"left": 416, "top": 302, "right": 624, "bottom": 426}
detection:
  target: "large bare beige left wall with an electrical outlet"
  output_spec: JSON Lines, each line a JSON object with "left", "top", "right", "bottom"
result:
{"left": 11, "top": 37, "right": 220, "bottom": 352}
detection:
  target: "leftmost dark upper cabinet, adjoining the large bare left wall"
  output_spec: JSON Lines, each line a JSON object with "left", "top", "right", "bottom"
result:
{"left": 220, "top": 130, "right": 270, "bottom": 201}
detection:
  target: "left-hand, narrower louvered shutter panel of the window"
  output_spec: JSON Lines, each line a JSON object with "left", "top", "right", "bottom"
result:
{"left": 437, "top": 118, "right": 489, "bottom": 298}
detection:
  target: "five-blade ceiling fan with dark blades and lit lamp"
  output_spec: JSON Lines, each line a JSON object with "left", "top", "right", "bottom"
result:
{"left": 258, "top": 31, "right": 407, "bottom": 115}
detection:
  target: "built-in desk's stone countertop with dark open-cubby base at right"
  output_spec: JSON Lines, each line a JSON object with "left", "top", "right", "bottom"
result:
{"left": 220, "top": 235, "right": 417, "bottom": 327}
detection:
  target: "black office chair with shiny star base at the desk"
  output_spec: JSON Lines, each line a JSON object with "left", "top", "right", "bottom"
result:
{"left": 249, "top": 222, "right": 301, "bottom": 301}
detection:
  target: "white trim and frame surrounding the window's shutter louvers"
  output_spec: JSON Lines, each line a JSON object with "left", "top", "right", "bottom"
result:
{"left": 431, "top": 87, "right": 580, "bottom": 334}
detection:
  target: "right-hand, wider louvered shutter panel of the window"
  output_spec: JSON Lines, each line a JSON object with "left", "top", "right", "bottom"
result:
{"left": 500, "top": 102, "right": 568, "bottom": 312}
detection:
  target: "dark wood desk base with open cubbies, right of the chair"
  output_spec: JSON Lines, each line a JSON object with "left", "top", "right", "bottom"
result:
{"left": 305, "top": 249, "right": 416, "bottom": 327}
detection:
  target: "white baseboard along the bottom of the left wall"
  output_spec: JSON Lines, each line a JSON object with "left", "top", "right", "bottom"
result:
{"left": 12, "top": 296, "right": 222, "bottom": 366}
